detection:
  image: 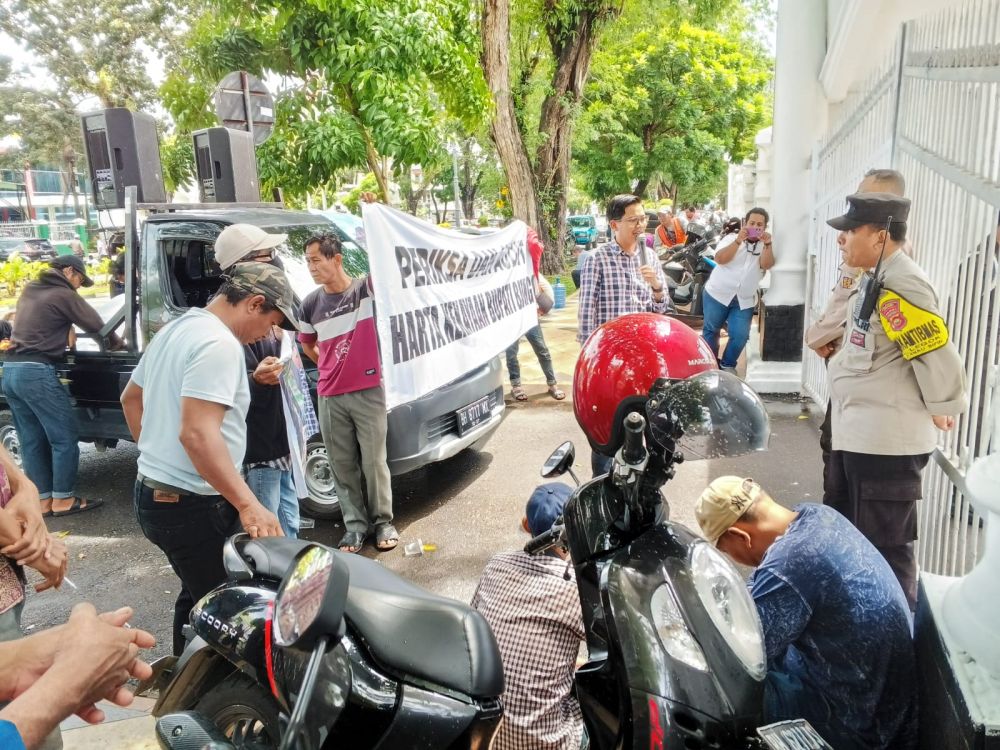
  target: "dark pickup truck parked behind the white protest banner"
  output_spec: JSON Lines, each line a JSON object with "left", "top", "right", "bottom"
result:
{"left": 0, "top": 194, "right": 504, "bottom": 518}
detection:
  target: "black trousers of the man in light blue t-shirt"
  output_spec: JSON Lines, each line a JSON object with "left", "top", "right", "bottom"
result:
{"left": 134, "top": 481, "right": 239, "bottom": 656}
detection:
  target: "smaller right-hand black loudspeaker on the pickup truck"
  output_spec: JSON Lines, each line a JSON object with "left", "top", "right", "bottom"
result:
{"left": 191, "top": 128, "right": 260, "bottom": 203}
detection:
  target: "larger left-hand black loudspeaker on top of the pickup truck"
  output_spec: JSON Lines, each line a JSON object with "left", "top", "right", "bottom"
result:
{"left": 80, "top": 107, "right": 167, "bottom": 210}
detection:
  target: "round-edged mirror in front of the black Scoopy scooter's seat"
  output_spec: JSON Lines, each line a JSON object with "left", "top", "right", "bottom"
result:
{"left": 274, "top": 544, "right": 350, "bottom": 650}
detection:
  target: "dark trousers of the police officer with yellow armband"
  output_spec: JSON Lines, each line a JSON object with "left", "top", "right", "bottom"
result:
{"left": 823, "top": 450, "right": 930, "bottom": 611}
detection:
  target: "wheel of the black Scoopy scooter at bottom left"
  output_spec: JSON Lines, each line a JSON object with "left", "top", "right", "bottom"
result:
{"left": 194, "top": 673, "right": 281, "bottom": 748}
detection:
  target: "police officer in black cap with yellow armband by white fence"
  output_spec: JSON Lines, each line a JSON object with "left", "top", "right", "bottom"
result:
{"left": 823, "top": 193, "right": 967, "bottom": 609}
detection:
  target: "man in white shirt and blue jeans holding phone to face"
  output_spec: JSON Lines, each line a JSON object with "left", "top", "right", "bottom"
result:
{"left": 701, "top": 208, "right": 774, "bottom": 372}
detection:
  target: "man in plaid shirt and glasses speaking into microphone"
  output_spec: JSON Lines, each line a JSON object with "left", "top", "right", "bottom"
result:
{"left": 576, "top": 195, "right": 671, "bottom": 344}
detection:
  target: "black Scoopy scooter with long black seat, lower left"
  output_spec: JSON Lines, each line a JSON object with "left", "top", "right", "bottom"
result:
{"left": 146, "top": 534, "right": 504, "bottom": 750}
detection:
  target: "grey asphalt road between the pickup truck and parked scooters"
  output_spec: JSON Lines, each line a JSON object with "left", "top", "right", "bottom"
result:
{"left": 24, "top": 397, "right": 821, "bottom": 655}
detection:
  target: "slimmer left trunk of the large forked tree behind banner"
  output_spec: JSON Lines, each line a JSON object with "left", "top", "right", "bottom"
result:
{"left": 482, "top": 0, "right": 539, "bottom": 232}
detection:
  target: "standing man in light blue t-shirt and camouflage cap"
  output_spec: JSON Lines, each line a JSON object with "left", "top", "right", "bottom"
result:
{"left": 121, "top": 262, "right": 299, "bottom": 654}
